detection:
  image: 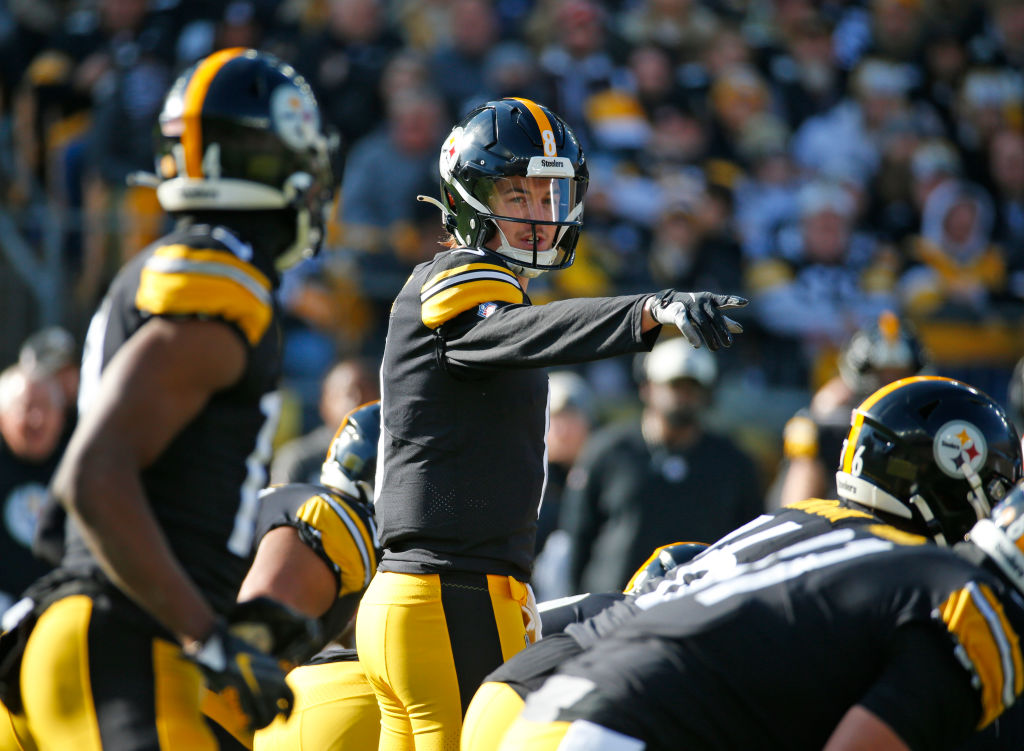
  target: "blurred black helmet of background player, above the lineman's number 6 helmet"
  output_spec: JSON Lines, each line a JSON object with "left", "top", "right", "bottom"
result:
{"left": 839, "top": 310, "right": 928, "bottom": 397}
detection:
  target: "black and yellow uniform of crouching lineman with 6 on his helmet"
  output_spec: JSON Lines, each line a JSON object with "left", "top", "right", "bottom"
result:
{"left": 462, "top": 498, "right": 903, "bottom": 751}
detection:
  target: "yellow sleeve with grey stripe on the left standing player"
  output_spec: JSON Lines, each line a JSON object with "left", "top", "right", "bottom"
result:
{"left": 135, "top": 245, "right": 273, "bottom": 346}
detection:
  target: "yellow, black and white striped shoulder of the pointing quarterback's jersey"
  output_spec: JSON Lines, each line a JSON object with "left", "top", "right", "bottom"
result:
{"left": 420, "top": 255, "right": 525, "bottom": 329}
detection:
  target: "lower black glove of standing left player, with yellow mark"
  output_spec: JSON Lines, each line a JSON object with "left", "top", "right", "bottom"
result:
{"left": 185, "top": 623, "right": 295, "bottom": 732}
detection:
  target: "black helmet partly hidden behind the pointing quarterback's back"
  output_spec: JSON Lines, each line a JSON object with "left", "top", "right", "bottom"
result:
{"left": 321, "top": 400, "right": 381, "bottom": 503}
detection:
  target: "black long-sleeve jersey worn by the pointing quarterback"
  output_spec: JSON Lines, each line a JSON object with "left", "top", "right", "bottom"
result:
{"left": 375, "top": 248, "right": 658, "bottom": 581}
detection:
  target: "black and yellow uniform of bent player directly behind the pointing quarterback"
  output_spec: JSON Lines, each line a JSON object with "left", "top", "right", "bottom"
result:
{"left": 203, "top": 483, "right": 380, "bottom": 751}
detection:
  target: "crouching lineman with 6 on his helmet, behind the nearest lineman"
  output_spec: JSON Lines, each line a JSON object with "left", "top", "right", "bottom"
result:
{"left": 462, "top": 376, "right": 1022, "bottom": 751}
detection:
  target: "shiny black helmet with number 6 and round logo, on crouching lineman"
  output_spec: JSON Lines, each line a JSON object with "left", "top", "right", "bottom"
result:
{"left": 836, "top": 376, "right": 1022, "bottom": 544}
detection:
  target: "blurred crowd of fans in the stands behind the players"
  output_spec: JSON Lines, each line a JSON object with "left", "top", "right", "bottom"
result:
{"left": 6, "top": 0, "right": 1024, "bottom": 590}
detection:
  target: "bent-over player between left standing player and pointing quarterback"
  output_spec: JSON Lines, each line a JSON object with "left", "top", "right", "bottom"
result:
{"left": 203, "top": 402, "right": 380, "bottom": 751}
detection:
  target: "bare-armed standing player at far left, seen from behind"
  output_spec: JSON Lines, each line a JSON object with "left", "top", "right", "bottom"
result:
{"left": 0, "top": 48, "right": 333, "bottom": 749}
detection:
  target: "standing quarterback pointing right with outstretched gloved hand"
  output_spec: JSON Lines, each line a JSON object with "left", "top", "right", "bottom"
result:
{"left": 356, "top": 98, "right": 745, "bottom": 751}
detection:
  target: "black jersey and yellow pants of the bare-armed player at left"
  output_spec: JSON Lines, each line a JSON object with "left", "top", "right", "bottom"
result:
{"left": 12, "top": 222, "right": 281, "bottom": 751}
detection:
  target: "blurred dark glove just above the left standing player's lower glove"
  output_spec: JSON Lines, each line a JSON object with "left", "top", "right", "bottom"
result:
{"left": 227, "top": 597, "right": 324, "bottom": 665}
